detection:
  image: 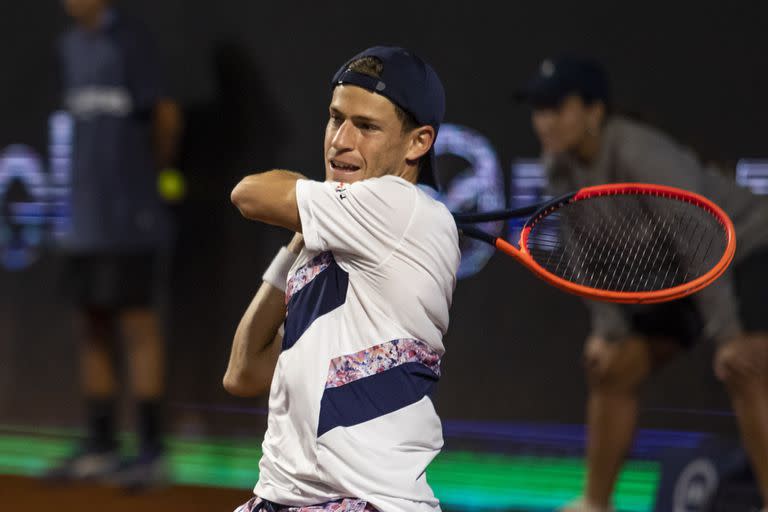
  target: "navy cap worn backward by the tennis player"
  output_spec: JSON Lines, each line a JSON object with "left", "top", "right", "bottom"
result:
{"left": 331, "top": 46, "right": 445, "bottom": 189}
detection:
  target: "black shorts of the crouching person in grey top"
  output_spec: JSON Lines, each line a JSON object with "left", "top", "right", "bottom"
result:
{"left": 628, "top": 248, "right": 768, "bottom": 347}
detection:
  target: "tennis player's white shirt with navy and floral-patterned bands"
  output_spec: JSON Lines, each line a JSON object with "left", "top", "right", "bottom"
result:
{"left": 254, "top": 176, "right": 460, "bottom": 512}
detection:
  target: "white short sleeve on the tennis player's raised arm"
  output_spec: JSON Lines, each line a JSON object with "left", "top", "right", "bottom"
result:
{"left": 296, "top": 176, "right": 417, "bottom": 269}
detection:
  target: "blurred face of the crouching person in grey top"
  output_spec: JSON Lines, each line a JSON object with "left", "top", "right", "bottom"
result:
{"left": 532, "top": 95, "right": 600, "bottom": 155}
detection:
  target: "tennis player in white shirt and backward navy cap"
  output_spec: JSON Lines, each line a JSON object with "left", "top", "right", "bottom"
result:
{"left": 224, "top": 46, "right": 460, "bottom": 512}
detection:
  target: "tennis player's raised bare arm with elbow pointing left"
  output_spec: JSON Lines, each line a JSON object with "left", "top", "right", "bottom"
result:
{"left": 231, "top": 170, "right": 306, "bottom": 233}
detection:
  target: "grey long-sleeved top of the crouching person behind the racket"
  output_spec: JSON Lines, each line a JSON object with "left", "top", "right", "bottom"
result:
{"left": 544, "top": 116, "right": 768, "bottom": 342}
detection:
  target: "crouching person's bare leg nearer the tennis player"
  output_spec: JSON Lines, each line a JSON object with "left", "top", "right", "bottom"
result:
{"left": 584, "top": 338, "right": 679, "bottom": 510}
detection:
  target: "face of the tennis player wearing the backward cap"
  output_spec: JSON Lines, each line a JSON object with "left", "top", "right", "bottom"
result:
{"left": 323, "top": 85, "right": 409, "bottom": 183}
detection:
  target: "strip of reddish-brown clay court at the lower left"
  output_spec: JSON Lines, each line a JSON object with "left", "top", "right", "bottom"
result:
{"left": 0, "top": 475, "right": 250, "bottom": 512}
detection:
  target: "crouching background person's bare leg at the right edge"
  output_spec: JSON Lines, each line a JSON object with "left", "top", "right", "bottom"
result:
{"left": 715, "top": 333, "right": 768, "bottom": 507}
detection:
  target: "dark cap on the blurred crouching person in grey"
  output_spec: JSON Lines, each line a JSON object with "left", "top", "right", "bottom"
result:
{"left": 515, "top": 56, "right": 611, "bottom": 108}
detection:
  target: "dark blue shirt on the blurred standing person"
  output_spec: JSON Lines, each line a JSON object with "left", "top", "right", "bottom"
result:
{"left": 59, "top": 12, "right": 169, "bottom": 252}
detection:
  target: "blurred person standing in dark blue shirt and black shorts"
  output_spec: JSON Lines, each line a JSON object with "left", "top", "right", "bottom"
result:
{"left": 47, "top": 0, "right": 181, "bottom": 489}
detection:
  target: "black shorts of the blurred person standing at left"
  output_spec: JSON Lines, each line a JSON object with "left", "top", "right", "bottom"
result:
{"left": 61, "top": 251, "right": 163, "bottom": 309}
